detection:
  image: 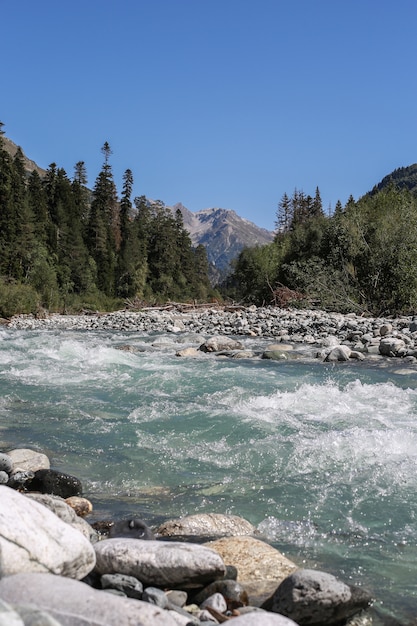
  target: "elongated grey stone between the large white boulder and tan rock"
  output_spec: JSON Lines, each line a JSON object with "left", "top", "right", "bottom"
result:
{"left": 94, "top": 538, "right": 226, "bottom": 588}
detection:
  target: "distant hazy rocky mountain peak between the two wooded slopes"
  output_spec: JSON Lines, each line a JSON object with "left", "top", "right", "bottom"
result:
{"left": 170, "top": 202, "right": 274, "bottom": 280}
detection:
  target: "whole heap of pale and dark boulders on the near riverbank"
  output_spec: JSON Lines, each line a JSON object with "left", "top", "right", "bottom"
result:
{"left": 0, "top": 449, "right": 372, "bottom": 626}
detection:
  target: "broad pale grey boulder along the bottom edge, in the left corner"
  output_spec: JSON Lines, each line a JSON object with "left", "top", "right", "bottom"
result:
{"left": 0, "top": 574, "right": 178, "bottom": 626}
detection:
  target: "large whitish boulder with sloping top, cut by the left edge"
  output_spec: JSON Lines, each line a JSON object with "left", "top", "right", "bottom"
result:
{"left": 0, "top": 486, "right": 95, "bottom": 576}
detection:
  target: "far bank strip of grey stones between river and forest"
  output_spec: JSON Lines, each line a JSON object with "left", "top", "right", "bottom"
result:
{"left": 7, "top": 305, "right": 417, "bottom": 363}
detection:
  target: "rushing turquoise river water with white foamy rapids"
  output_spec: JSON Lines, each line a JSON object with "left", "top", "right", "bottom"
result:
{"left": 0, "top": 329, "right": 417, "bottom": 624}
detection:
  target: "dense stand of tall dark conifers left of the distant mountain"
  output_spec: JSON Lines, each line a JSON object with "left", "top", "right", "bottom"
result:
{"left": 0, "top": 124, "right": 218, "bottom": 318}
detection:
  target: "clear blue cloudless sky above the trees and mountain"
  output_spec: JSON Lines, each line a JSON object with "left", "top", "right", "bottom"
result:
{"left": 0, "top": 0, "right": 417, "bottom": 229}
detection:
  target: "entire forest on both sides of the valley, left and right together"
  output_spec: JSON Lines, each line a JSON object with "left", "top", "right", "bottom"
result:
{"left": 0, "top": 118, "right": 417, "bottom": 318}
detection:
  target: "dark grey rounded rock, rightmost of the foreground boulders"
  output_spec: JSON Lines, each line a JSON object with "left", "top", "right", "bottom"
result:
{"left": 262, "top": 569, "right": 371, "bottom": 626}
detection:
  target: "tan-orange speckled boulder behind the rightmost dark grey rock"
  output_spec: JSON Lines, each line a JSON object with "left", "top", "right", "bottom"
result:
{"left": 204, "top": 537, "right": 298, "bottom": 585}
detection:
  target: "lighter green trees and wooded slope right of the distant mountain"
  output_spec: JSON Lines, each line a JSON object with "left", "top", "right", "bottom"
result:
{"left": 225, "top": 180, "right": 417, "bottom": 315}
